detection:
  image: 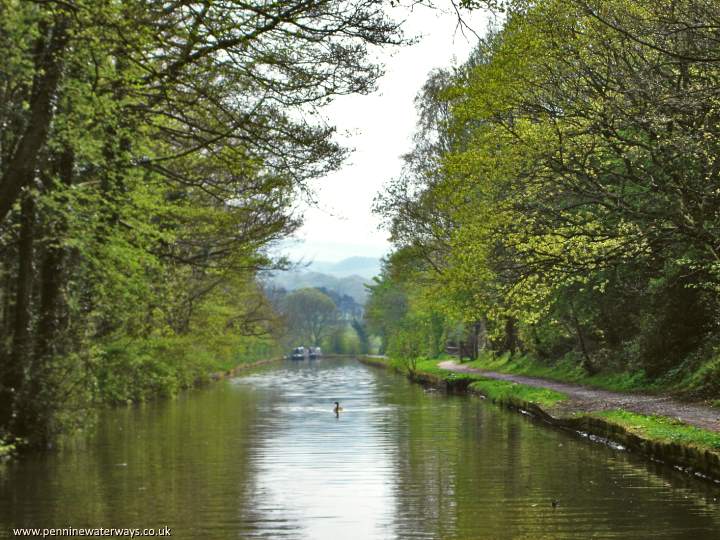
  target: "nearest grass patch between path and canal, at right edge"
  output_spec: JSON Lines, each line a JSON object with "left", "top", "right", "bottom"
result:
{"left": 592, "top": 409, "right": 720, "bottom": 451}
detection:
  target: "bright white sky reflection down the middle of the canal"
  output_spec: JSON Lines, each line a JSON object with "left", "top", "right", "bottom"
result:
{"left": 236, "top": 364, "right": 393, "bottom": 538}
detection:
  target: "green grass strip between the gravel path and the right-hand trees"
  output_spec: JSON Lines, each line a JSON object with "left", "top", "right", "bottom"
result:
{"left": 465, "top": 353, "right": 661, "bottom": 392}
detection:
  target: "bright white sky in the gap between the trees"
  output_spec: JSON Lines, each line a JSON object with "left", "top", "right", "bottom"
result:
{"left": 283, "top": 2, "right": 489, "bottom": 261}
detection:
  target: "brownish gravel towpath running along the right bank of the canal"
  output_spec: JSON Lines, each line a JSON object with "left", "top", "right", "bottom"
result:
{"left": 438, "top": 360, "right": 720, "bottom": 432}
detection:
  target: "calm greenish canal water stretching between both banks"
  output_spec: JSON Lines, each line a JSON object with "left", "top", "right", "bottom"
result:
{"left": 0, "top": 359, "right": 720, "bottom": 540}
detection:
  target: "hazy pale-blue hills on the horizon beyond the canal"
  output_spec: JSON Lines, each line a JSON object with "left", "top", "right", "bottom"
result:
{"left": 270, "top": 257, "right": 380, "bottom": 305}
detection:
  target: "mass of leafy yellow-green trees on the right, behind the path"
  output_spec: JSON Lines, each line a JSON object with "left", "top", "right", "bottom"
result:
{"left": 366, "top": 0, "right": 720, "bottom": 396}
